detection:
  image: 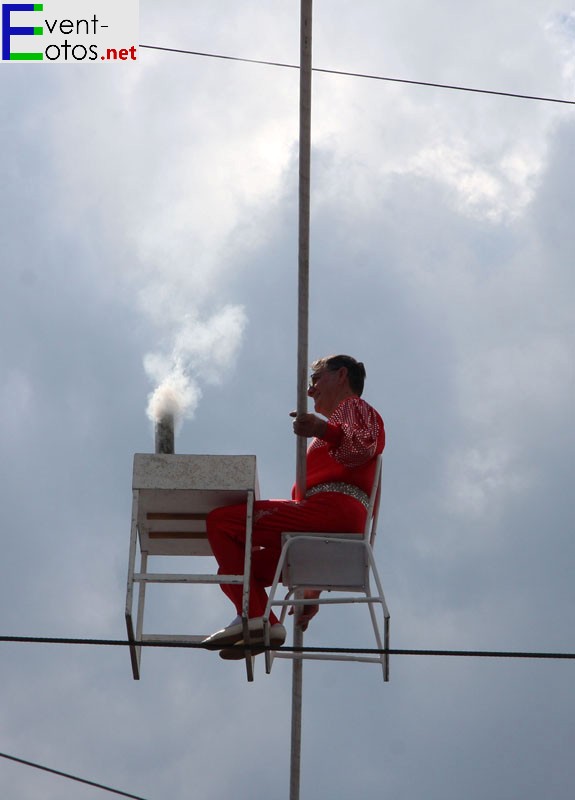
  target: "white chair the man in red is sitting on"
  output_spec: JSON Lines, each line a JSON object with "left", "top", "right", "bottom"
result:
{"left": 264, "top": 456, "right": 390, "bottom": 681}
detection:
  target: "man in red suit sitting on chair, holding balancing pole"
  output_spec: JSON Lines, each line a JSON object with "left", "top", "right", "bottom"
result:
{"left": 204, "top": 355, "right": 385, "bottom": 659}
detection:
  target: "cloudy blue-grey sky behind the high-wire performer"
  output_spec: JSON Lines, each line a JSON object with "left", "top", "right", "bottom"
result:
{"left": 0, "top": 0, "right": 575, "bottom": 800}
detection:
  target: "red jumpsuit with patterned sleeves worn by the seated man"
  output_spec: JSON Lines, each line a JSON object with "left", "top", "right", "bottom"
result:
{"left": 207, "top": 397, "right": 385, "bottom": 625}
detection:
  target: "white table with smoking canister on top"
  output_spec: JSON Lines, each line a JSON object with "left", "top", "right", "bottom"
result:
{"left": 125, "top": 453, "right": 259, "bottom": 681}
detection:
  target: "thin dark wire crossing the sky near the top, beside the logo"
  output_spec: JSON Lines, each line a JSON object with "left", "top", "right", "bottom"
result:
{"left": 139, "top": 44, "right": 575, "bottom": 106}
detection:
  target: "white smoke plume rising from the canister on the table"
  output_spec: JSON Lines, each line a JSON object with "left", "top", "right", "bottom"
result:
{"left": 144, "top": 305, "right": 247, "bottom": 424}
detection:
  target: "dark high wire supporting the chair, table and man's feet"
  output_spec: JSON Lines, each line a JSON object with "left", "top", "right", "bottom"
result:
{"left": 0, "top": 636, "right": 575, "bottom": 661}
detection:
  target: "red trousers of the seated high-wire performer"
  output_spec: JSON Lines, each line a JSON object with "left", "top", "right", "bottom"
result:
{"left": 207, "top": 492, "right": 366, "bottom": 624}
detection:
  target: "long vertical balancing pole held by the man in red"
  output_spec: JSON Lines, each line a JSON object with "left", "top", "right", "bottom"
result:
{"left": 290, "top": 0, "right": 313, "bottom": 800}
